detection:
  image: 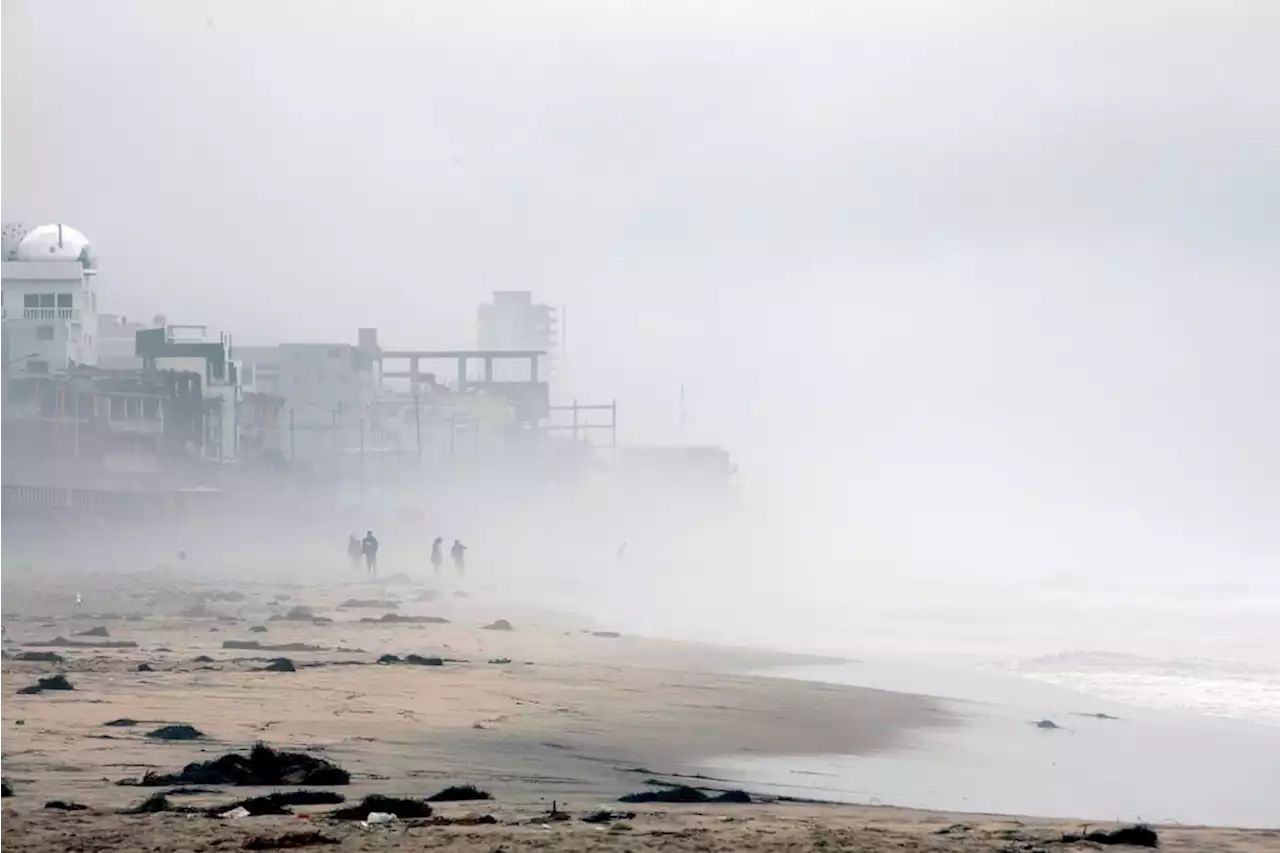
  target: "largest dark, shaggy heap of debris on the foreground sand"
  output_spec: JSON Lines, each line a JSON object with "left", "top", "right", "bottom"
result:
{"left": 122, "top": 743, "right": 351, "bottom": 788}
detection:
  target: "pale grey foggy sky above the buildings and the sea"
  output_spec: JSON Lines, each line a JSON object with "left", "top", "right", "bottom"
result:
{"left": 0, "top": 0, "right": 1280, "bottom": 568}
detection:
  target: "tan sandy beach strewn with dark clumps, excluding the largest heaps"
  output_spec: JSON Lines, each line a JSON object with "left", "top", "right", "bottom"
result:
{"left": 0, "top": 575, "right": 1280, "bottom": 850}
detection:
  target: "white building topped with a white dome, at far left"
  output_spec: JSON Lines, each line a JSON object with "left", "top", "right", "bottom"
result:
{"left": 0, "top": 223, "right": 97, "bottom": 377}
